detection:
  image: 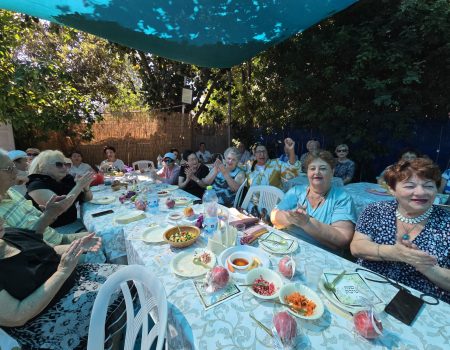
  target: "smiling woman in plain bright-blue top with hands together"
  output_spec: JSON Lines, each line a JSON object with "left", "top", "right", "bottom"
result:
{"left": 271, "top": 150, "right": 356, "bottom": 255}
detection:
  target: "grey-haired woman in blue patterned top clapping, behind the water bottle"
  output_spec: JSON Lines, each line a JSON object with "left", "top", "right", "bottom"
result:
{"left": 202, "top": 147, "right": 245, "bottom": 207}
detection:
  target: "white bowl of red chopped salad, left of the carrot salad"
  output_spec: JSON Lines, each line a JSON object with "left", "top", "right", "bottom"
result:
{"left": 245, "top": 267, "right": 283, "bottom": 299}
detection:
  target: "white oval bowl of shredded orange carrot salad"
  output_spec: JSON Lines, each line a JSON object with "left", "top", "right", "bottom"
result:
{"left": 279, "top": 283, "right": 324, "bottom": 320}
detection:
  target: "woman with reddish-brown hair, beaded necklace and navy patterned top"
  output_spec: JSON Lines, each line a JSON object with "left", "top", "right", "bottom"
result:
{"left": 350, "top": 158, "right": 450, "bottom": 303}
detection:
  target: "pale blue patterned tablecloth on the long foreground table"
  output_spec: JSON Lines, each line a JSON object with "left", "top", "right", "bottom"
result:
{"left": 0, "top": 185, "right": 450, "bottom": 350}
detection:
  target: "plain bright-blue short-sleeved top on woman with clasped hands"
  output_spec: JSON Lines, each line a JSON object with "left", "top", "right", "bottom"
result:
{"left": 276, "top": 185, "right": 356, "bottom": 255}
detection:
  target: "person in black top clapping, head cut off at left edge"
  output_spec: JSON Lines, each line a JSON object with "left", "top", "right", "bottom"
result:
{"left": 0, "top": 218, "right": 123, "bottom": 349}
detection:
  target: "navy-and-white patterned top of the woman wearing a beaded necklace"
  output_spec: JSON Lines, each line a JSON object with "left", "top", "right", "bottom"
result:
{"left": 356, "top": 201, "right": 450, "bottom": 303}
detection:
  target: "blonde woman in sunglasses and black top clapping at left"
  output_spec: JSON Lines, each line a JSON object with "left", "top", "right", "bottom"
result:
{"left": 25, "top": 150, "right": 94, "bottom": 233}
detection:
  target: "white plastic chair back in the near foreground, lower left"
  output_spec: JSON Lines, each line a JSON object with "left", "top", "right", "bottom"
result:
{"left": 87, "top": 265, "right": 167, "bottom": 350}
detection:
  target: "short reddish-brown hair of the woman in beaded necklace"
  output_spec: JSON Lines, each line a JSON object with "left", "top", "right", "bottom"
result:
{"left": 384, "top": 158, "right": 442, "bottom": 189}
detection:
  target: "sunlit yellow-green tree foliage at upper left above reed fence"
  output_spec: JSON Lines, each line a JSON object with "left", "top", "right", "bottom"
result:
{"left": 0, "top": 11, "right": 139, "bottom": 145}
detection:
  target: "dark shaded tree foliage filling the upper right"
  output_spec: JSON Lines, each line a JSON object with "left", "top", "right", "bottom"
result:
{"left": 205, "top": 0, "right": 450, "bottom": 159}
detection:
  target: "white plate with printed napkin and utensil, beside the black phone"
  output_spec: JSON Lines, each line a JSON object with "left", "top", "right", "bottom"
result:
{"left": 319, "top": 270, "right": 385, "bottom": 314}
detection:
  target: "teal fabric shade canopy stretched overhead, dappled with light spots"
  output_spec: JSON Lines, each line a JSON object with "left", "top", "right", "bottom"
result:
{"left": 0, "top": 0, "right": 357, "bottom": 68}
